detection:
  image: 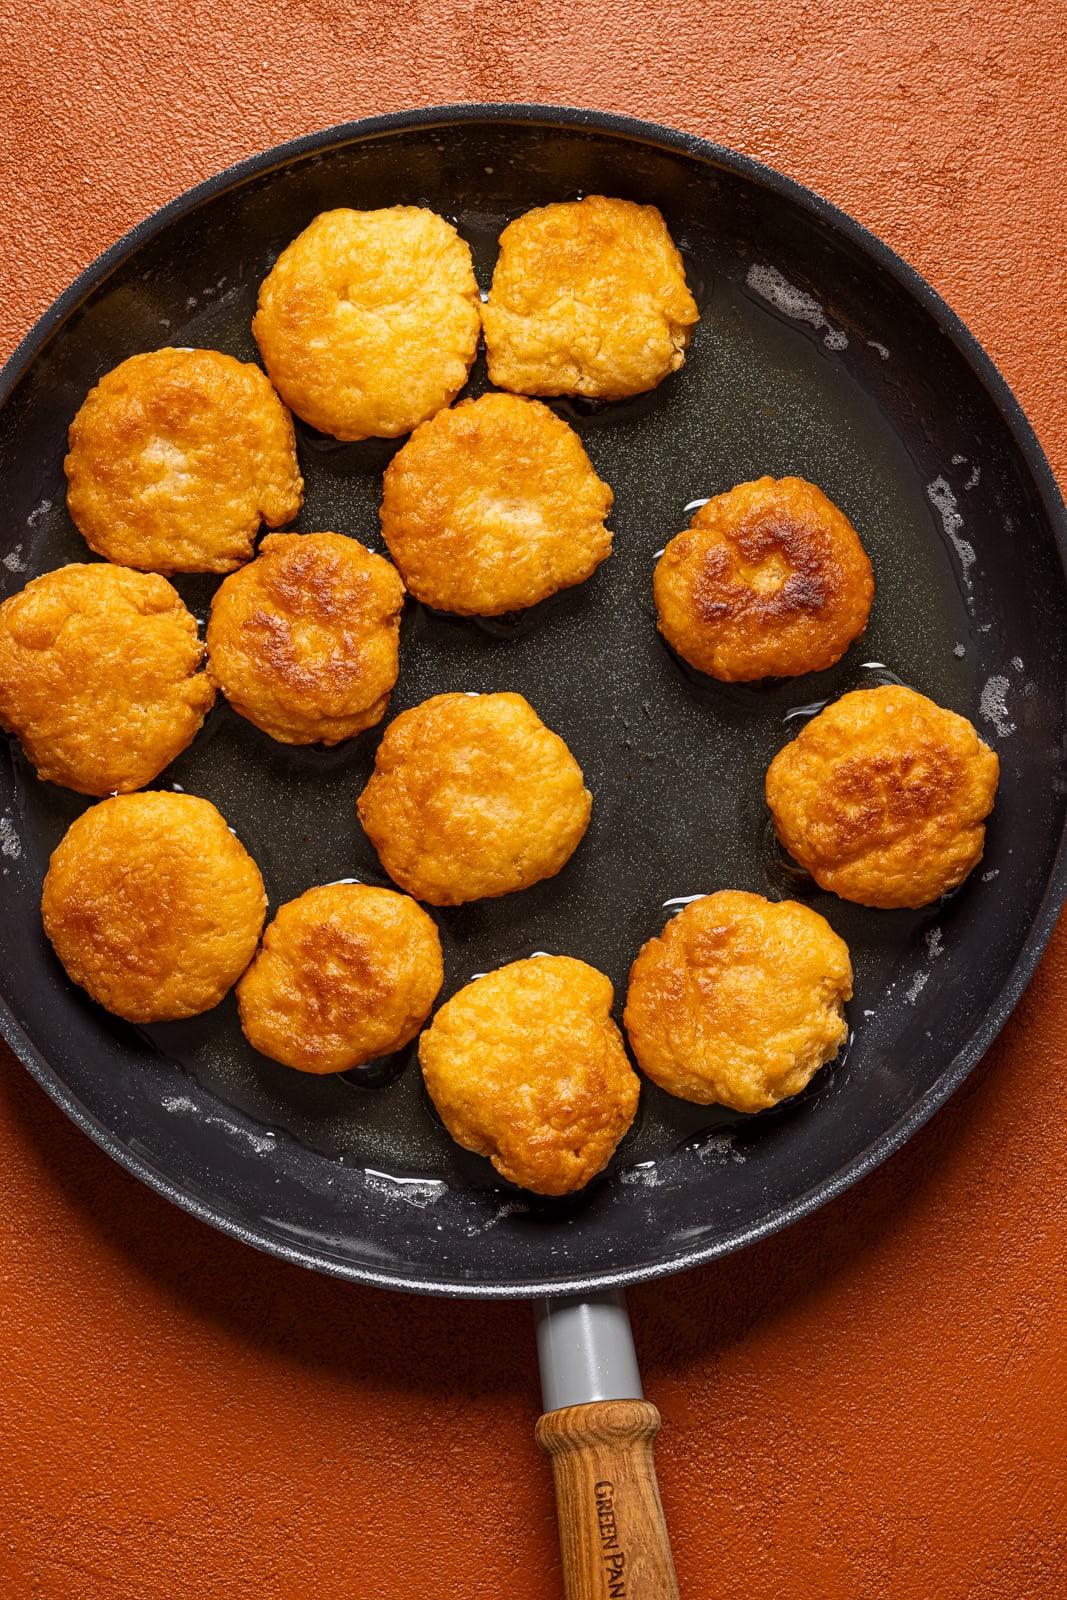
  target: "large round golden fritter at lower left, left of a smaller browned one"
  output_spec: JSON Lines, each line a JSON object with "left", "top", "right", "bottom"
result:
{"left": 42, "top": 790, "right": 267, "bottom": 1022}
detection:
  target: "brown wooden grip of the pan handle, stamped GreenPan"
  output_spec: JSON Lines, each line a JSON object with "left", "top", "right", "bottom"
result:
{"left": 536, "top": 1400, "right": 678, "bottom": 1600}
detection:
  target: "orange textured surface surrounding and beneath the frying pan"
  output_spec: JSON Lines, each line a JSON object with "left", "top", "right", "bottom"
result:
{"left": 0, "top": 0, "right": 1067, "bottom": 1600}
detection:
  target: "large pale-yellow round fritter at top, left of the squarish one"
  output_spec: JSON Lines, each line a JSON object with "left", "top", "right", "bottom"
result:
{"left": 253, "top": 205, "right": 482, "bottom": 438}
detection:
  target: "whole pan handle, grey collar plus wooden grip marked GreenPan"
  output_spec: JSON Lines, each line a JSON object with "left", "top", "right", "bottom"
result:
{"left": 534, "top": 1291, "right": 678, "bottom": 1600}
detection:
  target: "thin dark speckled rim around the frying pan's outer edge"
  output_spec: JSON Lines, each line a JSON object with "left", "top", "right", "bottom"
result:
{"left": 0, "top": 101, "right": 1067, "bottom": 1299}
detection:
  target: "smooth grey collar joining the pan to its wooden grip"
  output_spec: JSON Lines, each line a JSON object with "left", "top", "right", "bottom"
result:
{"left": 534, "top": 1290, "right": 645, "bottom": 1411}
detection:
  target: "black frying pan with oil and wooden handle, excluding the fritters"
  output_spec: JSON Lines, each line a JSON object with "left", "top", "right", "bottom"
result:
{"left": 0, "top": 106, "right": 1067, "bottom": 1597}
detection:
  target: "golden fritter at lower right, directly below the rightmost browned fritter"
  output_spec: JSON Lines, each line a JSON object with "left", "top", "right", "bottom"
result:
{"left": 624, "top": 890, "right": 853, "bottom": 1112}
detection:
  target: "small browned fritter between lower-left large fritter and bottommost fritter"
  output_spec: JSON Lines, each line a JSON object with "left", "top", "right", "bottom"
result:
{"left": 237, "top": 883, "right": 445, "bottom": 1072}
